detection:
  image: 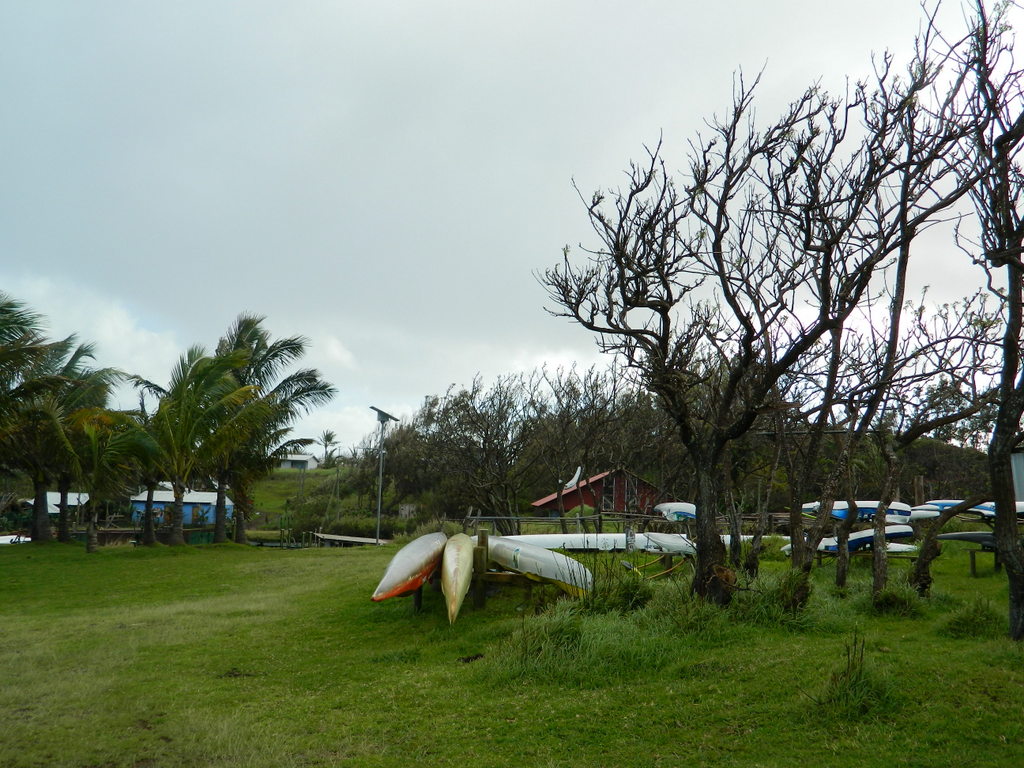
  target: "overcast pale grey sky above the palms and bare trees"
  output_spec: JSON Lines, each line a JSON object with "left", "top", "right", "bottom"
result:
{"left": 0, "top": 0, "right": 991, "bottom": 446}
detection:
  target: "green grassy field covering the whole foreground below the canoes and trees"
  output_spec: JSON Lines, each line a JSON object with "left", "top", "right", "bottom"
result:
{"left": 0, "top": 545, "right": 1024, "bottom": 768}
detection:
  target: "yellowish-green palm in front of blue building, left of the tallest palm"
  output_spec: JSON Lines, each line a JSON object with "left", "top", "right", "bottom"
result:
{"left": 133, "top": 346, "right": 256, "bottom": 545}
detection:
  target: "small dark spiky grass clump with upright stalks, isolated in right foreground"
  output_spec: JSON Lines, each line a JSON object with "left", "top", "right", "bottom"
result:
{"left": 810, "top": 631, "right": 898, "bottom": 721}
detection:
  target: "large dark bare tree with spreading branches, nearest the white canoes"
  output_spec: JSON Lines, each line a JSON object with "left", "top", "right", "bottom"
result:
{"left": 541, "top": 15, "right": 971, "bottom": 602}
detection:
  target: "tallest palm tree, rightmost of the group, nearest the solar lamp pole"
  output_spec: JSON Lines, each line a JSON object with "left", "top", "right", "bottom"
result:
{"left": 214, "top": 313, "right": 337, "bottom": 543}
